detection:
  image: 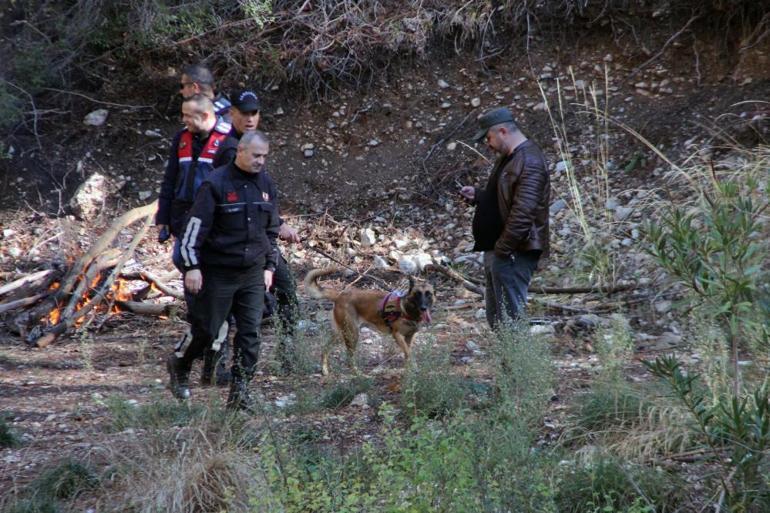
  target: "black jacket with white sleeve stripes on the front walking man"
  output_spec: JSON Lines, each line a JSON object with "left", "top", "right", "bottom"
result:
{"left": 180, "top": 163, "right": 278, "bottom": 271}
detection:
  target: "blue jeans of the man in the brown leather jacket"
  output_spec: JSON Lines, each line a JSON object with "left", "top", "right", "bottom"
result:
{"left": 484, "top": 251, "right": 541, "bottom": 329}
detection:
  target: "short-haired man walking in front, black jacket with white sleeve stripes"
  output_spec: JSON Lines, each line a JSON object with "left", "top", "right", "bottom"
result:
{"left": 167, "top": 131, "right": 278, "bottom": 409}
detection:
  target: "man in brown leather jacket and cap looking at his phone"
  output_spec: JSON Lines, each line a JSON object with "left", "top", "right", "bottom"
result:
{"left": 460, "top": 107, "right": 551, "bottom": 329}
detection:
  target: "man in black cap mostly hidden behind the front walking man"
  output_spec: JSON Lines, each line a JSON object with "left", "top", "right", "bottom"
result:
{"left": 217, "top": 89, "right": 300, "bottom": 372}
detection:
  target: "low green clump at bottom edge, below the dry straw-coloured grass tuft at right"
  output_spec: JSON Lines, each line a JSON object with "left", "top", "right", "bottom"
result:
{"left": 556, "top": 457, "right": 683, "bottom": 513}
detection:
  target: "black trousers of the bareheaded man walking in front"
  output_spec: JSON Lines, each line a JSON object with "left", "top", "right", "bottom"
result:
{"left": 177, "top": 265, "right": 265, "bottom": 380}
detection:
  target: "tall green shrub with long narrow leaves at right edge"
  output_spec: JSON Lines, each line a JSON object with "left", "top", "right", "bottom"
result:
{"left": 646, "top": 161, "right": 770, "bottom": 395}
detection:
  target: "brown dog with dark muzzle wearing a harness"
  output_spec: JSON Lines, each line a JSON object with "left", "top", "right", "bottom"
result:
{"left": 305, "top": 267, "right": 433, "bottom": 375}
